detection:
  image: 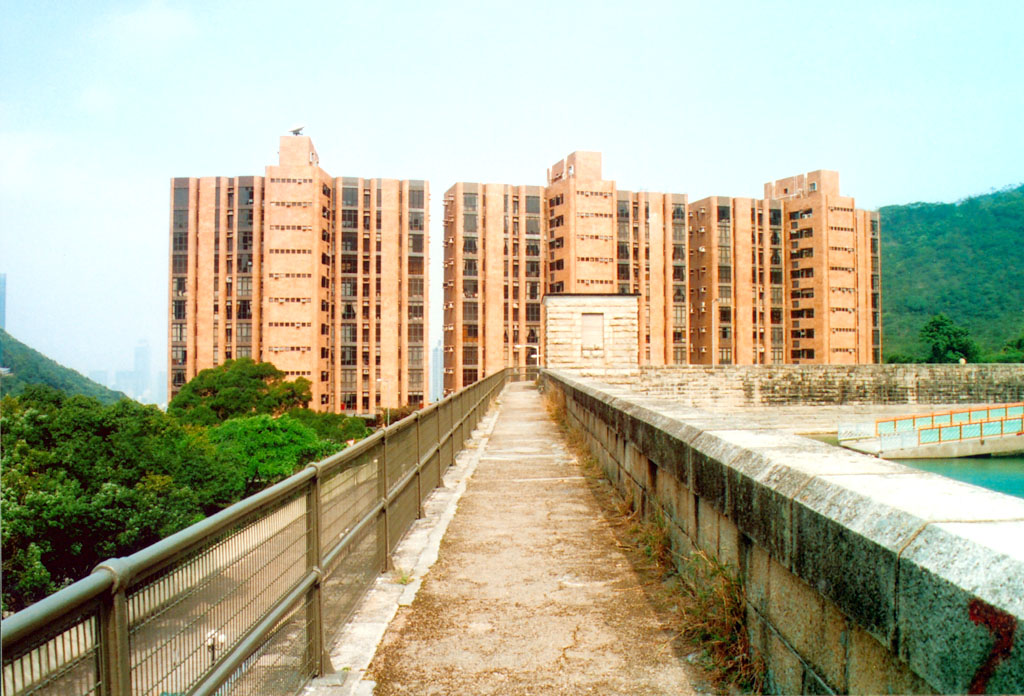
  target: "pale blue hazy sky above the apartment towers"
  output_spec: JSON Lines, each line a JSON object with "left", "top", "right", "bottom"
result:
{"left": 0, "top": 0, "right": 1024, "bottom": 397}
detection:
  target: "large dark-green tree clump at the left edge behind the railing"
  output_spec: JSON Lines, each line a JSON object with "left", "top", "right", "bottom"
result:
{"left": 0, "top": 387, "right": 234, "bottom": 609}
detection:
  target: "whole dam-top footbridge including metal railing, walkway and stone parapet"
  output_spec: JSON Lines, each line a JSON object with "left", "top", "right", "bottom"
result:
{"left": 2, "top": 371, "right": 1024, "bottom": 696}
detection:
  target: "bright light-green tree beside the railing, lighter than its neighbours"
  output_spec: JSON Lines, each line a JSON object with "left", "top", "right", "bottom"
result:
{"left": 209, "top": 414, "right": 338, "bottom": 494}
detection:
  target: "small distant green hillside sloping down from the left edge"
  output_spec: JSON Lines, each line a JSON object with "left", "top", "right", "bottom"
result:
{"left": 0, "top": 329, "right": 127, "bottom": 403}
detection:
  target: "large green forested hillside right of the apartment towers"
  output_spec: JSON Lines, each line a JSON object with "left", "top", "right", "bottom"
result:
{"left": 880, "top": 185, "right": 1024, "bottom": 355}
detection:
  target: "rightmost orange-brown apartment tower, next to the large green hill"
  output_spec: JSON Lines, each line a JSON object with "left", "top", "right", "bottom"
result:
{"left": 687, "top": 171, "right": 882, "bottom": 364}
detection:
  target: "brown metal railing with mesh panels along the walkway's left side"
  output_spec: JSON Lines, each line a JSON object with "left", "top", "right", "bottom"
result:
{"left": 0, "top": 369, "right": 512, "bottom": 696}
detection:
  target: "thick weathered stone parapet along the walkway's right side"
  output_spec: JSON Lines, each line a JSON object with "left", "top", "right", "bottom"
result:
{"left": 542, "top": 372, "right": 1024, "bottom": 694}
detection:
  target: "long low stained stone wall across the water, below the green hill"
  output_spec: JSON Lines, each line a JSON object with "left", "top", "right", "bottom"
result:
{"left": 606, "top": 364, "right": 1024, "bottom": 408}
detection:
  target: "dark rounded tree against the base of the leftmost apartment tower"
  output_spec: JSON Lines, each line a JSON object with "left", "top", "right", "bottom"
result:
{"left": 167, "top": 357, "right": 312, "bottom": 426}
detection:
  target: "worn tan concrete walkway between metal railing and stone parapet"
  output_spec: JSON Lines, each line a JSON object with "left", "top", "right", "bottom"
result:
{"left": 369, "top": 383, "right": 699, "bottom": 695}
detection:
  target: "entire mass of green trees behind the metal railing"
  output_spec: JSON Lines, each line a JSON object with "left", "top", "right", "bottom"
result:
{"left": 0, "top": 359, "right": 370, "bottom": 611}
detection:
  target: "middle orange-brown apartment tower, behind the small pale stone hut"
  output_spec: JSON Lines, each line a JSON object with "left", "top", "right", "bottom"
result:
{"left": 444, "top": 151, "right": 686, "bottom": 392}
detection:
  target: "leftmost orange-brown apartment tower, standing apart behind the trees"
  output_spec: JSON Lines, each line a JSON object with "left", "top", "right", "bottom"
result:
{"left": 168, "top": 135, "right": 429, "bottom": 414}
